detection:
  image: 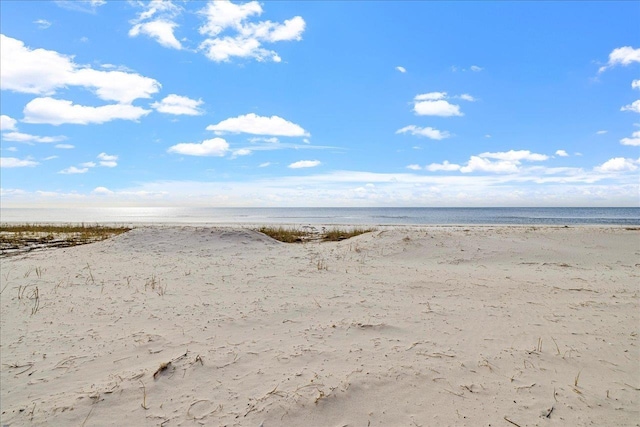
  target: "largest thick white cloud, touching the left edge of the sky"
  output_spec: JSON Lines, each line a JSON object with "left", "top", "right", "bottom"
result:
{"left": 0, "top": 34, "right": 161, "bottom": 104}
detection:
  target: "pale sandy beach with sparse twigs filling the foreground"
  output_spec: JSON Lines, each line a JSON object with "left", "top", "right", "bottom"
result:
{"left": 0, "top": 227, "right": 640, "bottom": 427}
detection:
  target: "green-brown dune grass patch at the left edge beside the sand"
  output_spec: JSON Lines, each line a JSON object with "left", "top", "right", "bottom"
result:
{"left": 0, "top": 224, "right": 131, "bottom": 254}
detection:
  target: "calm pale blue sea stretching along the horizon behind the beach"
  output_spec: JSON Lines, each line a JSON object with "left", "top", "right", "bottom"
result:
{"left": 0, "top": 207, "right": 640, "bottom": 225}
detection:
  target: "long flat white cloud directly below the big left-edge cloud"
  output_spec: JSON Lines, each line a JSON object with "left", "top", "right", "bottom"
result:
{"left": 23, "top": 97, "right": 151, "bottom": 125}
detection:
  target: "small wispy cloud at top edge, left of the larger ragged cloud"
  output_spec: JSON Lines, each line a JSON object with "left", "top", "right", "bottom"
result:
{"left": 129, "top": 0, "right": 182, "bottom": 50}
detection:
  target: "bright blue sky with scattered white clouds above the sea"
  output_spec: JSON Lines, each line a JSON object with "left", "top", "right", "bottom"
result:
{"left": 0, "top": 0, "right": 640, "bottom": 207}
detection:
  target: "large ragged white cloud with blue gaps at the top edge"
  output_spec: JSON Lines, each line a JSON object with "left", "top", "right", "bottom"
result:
{"left": 199, "top": 1, "right": 306, "bottom": 62}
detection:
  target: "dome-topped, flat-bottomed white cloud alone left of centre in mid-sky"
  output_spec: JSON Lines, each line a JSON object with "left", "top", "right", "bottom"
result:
{"left": 207, "top": 113, "right": 309, "bottom": 136}
